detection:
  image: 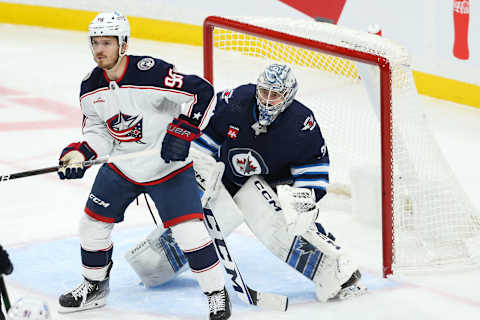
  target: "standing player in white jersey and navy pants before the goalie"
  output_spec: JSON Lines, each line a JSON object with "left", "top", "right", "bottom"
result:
{"left": 58, "top": 12, "right": 231, "bottom": 319}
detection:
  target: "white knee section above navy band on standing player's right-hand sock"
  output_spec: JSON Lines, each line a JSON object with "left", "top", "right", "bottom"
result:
{"left": 170, "top": 219, "right": 211, "bottom": 251}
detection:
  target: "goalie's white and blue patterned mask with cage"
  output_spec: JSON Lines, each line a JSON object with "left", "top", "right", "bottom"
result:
{"left": 256, "top": 63, "right": 298, "bottom": 126}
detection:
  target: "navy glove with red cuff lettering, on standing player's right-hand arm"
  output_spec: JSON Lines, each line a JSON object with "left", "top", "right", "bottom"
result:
{"left": 160, "top": 116, "right": 202, "bottom": 163}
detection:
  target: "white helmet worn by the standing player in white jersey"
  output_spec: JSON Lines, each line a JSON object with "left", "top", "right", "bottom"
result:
{"left": 88, "top": 11, "right": 130, "bottom": 60}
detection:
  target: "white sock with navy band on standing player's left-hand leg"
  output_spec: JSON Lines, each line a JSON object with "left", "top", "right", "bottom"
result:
{"left": 79, "top": 215, "right": 114, "bottom": 281}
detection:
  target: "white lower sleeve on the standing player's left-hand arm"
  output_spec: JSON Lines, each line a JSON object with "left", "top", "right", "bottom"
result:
{"left": 81, "top": 103, "right": 114, "bottom": 157}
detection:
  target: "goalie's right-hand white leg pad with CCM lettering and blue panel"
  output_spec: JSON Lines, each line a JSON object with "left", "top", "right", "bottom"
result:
{"left": 234, "top": 176, "right": 358, "bottom": 301}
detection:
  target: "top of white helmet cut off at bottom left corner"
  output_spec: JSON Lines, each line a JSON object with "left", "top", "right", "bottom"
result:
{"left": 7, "top": 297, "right": 51, "bottom": 320}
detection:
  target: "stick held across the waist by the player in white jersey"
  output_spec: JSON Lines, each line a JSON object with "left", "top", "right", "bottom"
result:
{"left": 0, "top": 149, "right": 160, "bottom": 182}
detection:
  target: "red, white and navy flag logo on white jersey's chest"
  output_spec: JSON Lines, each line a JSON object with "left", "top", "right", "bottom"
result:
{"left": 107, "top": 112, "right": 144, "bottom": 144}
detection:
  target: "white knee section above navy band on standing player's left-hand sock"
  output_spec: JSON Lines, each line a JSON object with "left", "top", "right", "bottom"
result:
{"left": 78, "top": 215, "right": 114, "bottom": 251}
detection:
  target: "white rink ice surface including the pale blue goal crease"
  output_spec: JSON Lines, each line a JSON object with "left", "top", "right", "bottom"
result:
{"left": 0, "top": 25, "right": 480, "bottom": 320}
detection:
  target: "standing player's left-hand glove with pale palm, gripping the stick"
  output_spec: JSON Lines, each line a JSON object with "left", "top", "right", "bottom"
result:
{"left": 57, "top": 141, "right": 97, "bottom": 180}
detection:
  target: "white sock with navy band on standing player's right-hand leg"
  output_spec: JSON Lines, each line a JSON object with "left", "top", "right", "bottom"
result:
{"left": 171, "top": 220, "right": 225, "bottom": 292}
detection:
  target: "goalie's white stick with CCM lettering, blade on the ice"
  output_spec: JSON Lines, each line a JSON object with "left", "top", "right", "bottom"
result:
{"left": 204, "top": 209, "right": 288, "bottom": 311}
